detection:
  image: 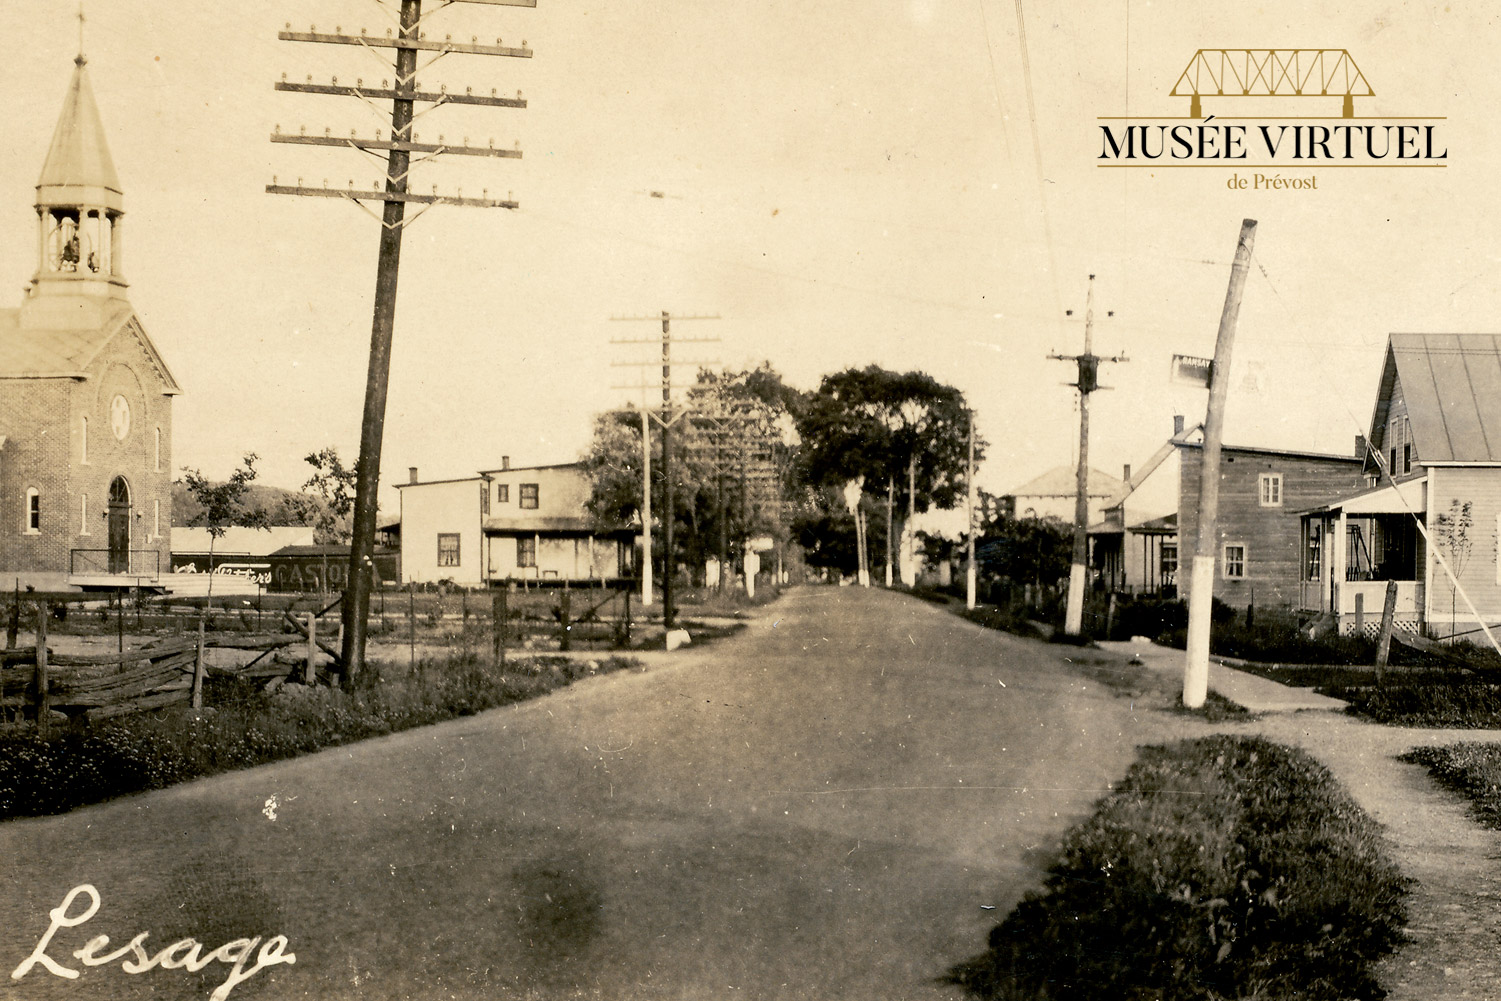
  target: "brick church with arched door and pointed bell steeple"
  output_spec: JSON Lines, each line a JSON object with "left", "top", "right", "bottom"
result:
{"left": 0, "top": 54, "right": 180, "bottom": 590}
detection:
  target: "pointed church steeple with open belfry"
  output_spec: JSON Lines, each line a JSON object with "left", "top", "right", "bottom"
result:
{"left": 33, "top": 51, "right": 126, "bottom": 297}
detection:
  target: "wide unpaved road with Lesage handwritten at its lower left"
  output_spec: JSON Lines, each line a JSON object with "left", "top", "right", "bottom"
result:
{"left": 0, "top": 588, "right": 1166, "bottom": 999}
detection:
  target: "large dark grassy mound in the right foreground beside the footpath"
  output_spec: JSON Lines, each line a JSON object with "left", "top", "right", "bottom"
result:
{"left": 950, "top": 735, "right": 1406, "bottom": 1001}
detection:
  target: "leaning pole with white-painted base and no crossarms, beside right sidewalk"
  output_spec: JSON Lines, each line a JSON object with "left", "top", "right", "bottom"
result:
{"left": 1183, "top": 219, "right": 1256, "bottom": 708}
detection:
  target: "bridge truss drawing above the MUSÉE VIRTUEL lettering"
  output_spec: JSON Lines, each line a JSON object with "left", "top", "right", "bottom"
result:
{"left": 1171, "top": 48, "right": 1376, "bottom": 98}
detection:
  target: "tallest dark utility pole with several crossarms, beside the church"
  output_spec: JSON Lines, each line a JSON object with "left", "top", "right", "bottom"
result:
{"left": 266, "top": 0, "right": 537, "bottom": 686}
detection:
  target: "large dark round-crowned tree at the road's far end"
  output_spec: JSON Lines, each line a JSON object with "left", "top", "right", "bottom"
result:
{"left": 797, "top": 365, "right": 985, "bottom": 582}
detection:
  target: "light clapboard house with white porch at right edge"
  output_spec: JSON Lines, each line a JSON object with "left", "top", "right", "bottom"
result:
{"left": 1300, "top": 333, "right": 1501, "bottom": 638}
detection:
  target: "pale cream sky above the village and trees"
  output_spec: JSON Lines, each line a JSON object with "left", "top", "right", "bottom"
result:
{"left": 0, "top": 0, "right": 1501, "bottom": 525}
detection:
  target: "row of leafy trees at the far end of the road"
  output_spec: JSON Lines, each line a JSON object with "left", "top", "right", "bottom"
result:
{"left": 584, "top": 363, "right": 985, "bottom": 582}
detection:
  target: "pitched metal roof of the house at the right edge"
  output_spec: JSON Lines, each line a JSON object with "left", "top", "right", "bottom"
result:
{"left": 1370, "top": 333, "right": 1501, "bottom": 462}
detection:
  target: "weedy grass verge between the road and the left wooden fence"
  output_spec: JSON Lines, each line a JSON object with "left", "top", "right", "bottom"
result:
{"left": 0, "top": 654, "right": 636, "bottom": 818}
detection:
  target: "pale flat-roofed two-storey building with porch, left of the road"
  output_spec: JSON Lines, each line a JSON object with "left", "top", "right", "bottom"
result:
{"left": 398, "top": 459, "right": 633, "bottom": 587}
